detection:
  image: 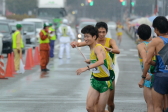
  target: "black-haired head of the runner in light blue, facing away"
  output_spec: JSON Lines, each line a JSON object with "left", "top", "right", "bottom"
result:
{"left": 137, "top": 24, "right": 151, "bottom": 41}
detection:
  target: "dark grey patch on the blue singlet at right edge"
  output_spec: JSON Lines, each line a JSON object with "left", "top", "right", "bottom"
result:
{"left": 159, "top": 44, "right": 168, "bottom": 65}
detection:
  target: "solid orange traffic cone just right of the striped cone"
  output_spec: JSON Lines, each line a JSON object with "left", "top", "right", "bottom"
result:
{"left": 5, "top": 54, "right": 14, "bottom": 77}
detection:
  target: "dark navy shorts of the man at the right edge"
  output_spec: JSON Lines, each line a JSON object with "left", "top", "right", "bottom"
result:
{"left": 153, "top": 73, "right": 168, "bottom": 95}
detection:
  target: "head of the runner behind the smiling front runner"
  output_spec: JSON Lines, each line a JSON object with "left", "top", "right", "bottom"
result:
{"left": 96, "top": 22, "right": 108, "bottom": 39}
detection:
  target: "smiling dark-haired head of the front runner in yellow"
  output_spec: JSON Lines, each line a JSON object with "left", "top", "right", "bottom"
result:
{"left": 81, "top": 25, "right": 98, "bottom": 45}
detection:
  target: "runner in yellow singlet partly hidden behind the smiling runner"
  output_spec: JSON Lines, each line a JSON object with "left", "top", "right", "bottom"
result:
{"left": 71, "top": 22, "right": 120, "bottom": 112}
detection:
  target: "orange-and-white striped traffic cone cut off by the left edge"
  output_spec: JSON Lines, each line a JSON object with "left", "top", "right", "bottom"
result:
{"left": 0, "top": 55, "right": 8, "bottom": 79}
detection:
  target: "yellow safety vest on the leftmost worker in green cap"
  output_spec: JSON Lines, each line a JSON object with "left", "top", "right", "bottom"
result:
{"left": 12, "top": 31, "right": 24, "bottom": 49}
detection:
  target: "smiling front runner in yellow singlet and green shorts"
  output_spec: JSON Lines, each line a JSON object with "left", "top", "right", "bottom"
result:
{"left": 77, "top": 25, "right": 112, "bottom": 112}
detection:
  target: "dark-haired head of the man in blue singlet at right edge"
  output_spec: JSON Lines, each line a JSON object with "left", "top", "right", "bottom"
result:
{"left": 152, "top": 16, "right": 168, "bottom": 36}
